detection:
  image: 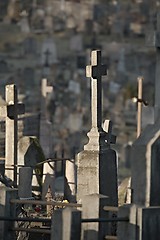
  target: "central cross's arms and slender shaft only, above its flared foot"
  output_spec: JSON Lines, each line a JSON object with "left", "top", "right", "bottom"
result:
{"left": 86, "top": 50, "right": 107, "bottom": 130}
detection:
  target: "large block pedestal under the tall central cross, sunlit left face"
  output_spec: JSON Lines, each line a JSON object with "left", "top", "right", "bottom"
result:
{"left": 77, "top": 148, "right": 118, "bottom": 206}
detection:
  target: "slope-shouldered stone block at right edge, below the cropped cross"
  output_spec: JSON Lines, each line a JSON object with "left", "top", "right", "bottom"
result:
{"left": 131, "top": 123, "right": 160, "bottom": 207}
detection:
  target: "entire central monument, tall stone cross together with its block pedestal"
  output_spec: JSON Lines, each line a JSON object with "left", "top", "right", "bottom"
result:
{"left": 77, "top": 50, "right": 118, "bottom": 239}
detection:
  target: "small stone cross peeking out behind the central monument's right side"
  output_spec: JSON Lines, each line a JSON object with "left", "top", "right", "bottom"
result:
{"left": 103, "top": 120, "right": 116, "bottom": 144}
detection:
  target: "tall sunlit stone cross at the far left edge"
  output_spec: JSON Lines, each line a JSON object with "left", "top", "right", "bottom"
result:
{"left": 0, "top": 84, "right": 25, "bottom": 186}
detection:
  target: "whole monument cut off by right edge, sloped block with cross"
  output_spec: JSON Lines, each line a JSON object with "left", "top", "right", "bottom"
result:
{"left": 131, "top": 13, "right": 160, "bottom": 207}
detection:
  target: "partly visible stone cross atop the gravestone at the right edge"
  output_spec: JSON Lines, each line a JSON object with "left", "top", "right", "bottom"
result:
{"left": 146, "top": 12, "right": 160, "bottom": 121}
